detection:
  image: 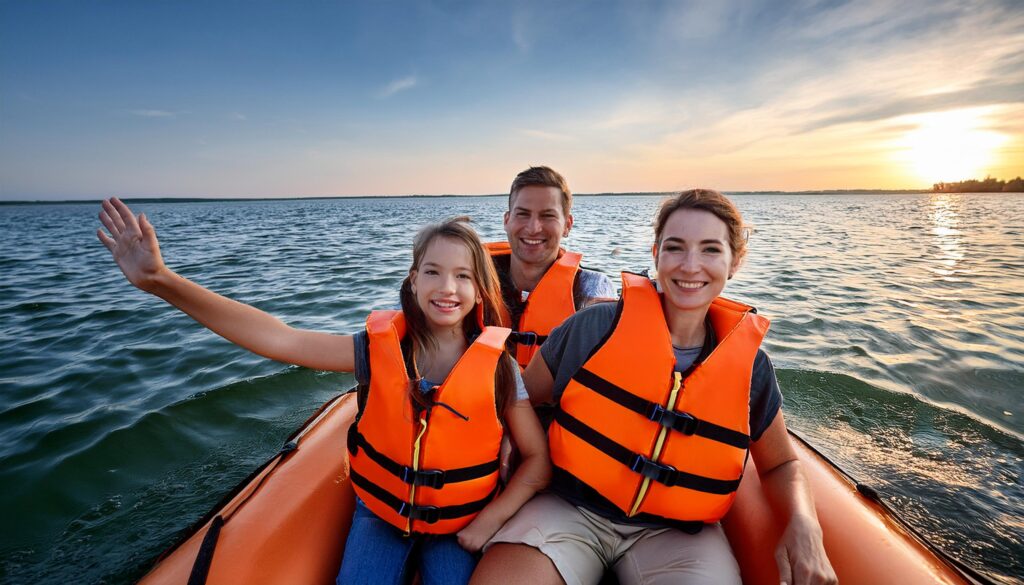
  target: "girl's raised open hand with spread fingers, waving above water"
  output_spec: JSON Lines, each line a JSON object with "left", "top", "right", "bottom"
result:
{"left": 96, "top": 197, "right": 164, "bottom": 292}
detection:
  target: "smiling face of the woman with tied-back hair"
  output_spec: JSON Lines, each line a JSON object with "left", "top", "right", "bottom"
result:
{"left": 652, "top": 209, "right": 738, "bottom": 310}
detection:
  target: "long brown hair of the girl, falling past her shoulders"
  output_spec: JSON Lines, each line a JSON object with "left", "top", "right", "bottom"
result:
{"left": 398, "top": 215, "right": 516, "bottom": 418}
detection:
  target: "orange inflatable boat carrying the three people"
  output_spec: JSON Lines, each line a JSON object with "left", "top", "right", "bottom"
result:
{"left": 140, "top": 392, "right": 991, "bottom": 585}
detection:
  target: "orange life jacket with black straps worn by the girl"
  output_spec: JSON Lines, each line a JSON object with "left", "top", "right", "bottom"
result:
{"left": 348, "top": 310, "right": 509, "bottom": 534}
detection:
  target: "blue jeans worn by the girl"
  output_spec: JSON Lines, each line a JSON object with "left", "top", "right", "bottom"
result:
{"left": 337, "top": 498, "right": 476, "bottom": 585}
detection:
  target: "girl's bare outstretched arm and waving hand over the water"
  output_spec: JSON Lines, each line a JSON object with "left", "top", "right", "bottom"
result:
{"left": 96, "top": 198, "right": 355, "bottom": 372}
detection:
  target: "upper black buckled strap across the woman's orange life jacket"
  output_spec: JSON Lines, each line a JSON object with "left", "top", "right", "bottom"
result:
{"left": 572, "top": 368, "right": 751, "bottom": 449}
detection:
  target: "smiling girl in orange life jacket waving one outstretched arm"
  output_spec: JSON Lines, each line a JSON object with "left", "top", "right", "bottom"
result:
{"left": 97, "top": 199, "right": 550, "bottom": 585}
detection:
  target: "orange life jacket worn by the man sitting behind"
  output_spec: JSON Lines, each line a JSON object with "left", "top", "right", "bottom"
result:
{"left": 483, "top": 242, "right": 583, "bottom": 368}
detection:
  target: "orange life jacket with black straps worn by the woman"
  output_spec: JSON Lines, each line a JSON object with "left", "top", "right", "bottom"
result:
{"left": 548, "top": 273, "right": 768, "bottom": 526}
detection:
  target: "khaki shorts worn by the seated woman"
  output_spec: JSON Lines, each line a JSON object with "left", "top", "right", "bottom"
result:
{"left": 487, "top": 494, "right": 740, "bottom": 585}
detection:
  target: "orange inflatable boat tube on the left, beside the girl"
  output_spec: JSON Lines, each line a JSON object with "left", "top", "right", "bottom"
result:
{"left": 140, "top": 392, "right": 356, "bottom": 585}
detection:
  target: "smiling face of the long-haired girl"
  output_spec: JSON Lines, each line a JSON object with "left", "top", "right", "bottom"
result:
{"left": 412, "top": 237, "right": 480, "bottom": 332}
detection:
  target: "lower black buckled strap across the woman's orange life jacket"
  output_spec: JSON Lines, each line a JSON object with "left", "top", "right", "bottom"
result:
{"left": 555, "top": 409, "right": 739, "bottom": 495}
